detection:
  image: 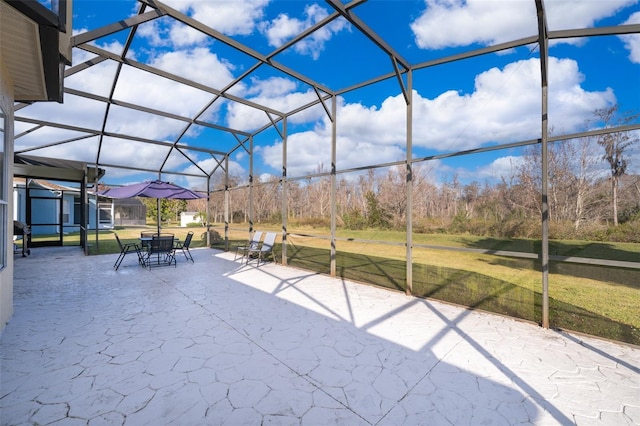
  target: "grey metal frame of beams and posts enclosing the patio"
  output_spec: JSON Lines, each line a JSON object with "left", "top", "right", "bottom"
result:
{"left": 8, "top": 0, "right": 640, "bottom": 327}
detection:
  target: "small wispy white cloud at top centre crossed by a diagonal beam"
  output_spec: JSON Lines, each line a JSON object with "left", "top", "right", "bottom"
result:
{"left": 261, "top": 4, "right": 347, "bottom": 59}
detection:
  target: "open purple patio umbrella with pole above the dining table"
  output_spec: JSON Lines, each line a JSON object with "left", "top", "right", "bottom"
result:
{"left": 98, "top": 180, "right": 206, "bottom": 233}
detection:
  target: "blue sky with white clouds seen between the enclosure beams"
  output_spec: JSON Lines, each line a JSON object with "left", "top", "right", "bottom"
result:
{"left": 16, "top": 0, "right": 640, "bottom": 190}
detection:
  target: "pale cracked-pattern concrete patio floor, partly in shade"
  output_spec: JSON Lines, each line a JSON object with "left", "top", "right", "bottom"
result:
{"left": 0, "top": 248, "right": 640, "bottom": 425}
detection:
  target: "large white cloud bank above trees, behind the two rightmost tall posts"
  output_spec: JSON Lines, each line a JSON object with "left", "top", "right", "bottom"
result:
{"left": 330, "top": 58, "right": 615, "bottom": 151}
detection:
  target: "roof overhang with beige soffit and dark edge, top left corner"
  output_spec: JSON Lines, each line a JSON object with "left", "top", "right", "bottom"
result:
{"left": 0, "top": 0, "right": 70, "bottom": 102}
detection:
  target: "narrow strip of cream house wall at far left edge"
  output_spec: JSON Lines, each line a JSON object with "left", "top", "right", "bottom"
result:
{"left": 0, "top": 52, "right": 13, "bottom": 331}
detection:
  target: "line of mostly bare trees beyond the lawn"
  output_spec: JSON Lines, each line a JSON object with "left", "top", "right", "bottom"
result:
{"left": 199, "top": 106, "right": 640, "bottom": 242}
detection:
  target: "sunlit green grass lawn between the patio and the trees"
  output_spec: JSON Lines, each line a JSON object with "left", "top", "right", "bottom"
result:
{"left": 41, "top": 225, "right": 640, "bottom": 345}
